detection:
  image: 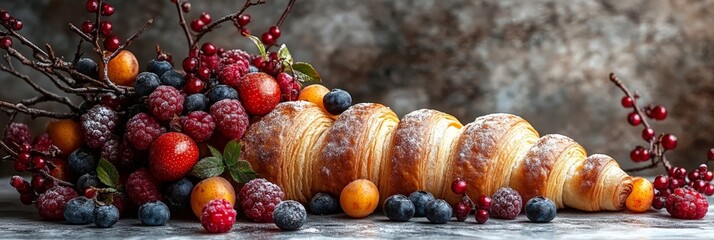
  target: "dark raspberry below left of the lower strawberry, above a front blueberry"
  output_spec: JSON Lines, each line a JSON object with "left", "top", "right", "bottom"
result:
{"left": 125, "top": 168, "right": 162, "bottom": 206}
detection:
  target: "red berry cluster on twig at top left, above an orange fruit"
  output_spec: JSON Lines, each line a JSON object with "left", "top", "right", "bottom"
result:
{"left": 81, "top": 0, "right": 121, "bottom": 52}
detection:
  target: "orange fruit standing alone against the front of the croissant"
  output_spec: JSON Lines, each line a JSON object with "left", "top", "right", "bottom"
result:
{"left": 340, "top": 179, "right": 379, "bottom": 218}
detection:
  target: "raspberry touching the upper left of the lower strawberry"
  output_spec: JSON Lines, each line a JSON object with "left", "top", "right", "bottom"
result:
{"left": 125, "top": 113, "right": 165, "bottom": 150}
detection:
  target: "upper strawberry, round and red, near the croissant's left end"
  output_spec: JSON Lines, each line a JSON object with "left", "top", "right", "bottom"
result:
{"left": 238, "top": 72, "right": 280, "bottom": 116}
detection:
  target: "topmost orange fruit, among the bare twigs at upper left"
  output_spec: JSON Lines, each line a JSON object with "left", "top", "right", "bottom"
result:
{"left": 99, "top": 50, "right": 139, "bottom": 86}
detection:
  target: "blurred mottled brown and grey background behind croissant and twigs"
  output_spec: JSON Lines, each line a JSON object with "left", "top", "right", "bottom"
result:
{"left": 0, "top": 0, "right": 714, "bottom": 175}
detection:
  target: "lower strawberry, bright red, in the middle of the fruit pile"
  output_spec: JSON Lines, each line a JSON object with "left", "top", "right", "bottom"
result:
{"left": 149, "top": 132, "right": 198, "bottom": 181}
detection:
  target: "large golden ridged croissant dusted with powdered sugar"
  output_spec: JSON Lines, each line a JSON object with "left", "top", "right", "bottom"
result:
{"left": 242, "top": 101, "right": 632, "bottom": 211}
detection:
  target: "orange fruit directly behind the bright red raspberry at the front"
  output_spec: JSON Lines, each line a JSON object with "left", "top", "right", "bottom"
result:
{"left": 191, "top": 177, "right": 236, "bottom": 218}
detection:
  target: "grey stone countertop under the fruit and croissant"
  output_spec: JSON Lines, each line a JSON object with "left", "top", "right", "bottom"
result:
{"left": 0, "top": 178, "right": 714, "bottom": 239}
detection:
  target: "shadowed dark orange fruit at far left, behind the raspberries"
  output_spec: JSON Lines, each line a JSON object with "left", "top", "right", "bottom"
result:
{"left": 47, "top": 119, "right": 84, "bottom": 157}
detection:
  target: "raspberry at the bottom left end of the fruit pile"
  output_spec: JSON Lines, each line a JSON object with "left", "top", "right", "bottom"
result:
{"left": 35, "top": 186, "right": 79, "bottom": 221}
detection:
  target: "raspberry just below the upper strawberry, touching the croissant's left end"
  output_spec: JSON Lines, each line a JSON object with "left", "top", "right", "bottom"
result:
{"left": 211, "top": 99, "right": 248, "bottom": 139}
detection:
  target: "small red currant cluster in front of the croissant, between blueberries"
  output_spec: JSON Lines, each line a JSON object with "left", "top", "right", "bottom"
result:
{"left": 451, "top": 178, "right": 492, "bottom": 224}
